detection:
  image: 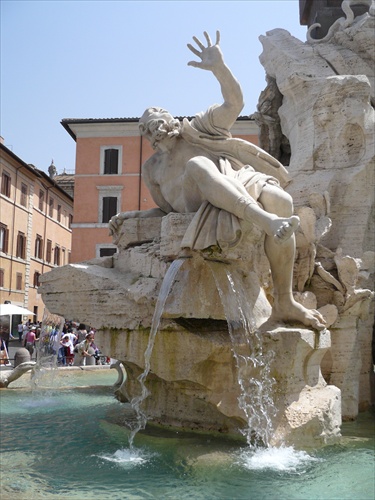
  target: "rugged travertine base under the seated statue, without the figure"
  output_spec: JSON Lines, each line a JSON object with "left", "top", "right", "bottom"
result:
{"left": 42, "top": 213, "right": 341, "bottom": 447}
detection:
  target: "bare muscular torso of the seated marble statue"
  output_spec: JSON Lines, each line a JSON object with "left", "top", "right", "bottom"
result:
{"left": 143, "top": 137, "right": 219, "bottom": 213}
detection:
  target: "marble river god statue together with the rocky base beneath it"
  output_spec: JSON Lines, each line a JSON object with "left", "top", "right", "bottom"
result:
{"left": 40, "top": 33, "right": 341, "bottom": 446}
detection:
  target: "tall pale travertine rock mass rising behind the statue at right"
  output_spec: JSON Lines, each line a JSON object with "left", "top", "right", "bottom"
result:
{"left": 260, "top": 0, "right": 375, "bottom": 418}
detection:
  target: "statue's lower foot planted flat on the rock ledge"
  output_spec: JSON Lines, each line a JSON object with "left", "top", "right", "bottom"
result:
{"left": 270, "top": 300, "right": 327, "bottom": 330}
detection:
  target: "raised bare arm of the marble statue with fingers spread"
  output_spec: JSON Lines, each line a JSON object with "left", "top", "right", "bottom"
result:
{"left": 188, "top": 31, "right": 244, "bottom": 130}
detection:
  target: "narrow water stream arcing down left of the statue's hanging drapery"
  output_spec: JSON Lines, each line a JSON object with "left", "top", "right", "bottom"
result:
{"left": 129, "top": 259, "right": 186, "bottom": 448}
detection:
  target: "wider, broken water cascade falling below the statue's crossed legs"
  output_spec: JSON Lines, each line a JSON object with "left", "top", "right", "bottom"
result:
{"left": 208, "top": 261, "right": 276, "bottom": 448}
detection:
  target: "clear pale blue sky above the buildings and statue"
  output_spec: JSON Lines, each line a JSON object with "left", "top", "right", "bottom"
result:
{"left": 0, "top": 0, "right": 306, "bottom": 173}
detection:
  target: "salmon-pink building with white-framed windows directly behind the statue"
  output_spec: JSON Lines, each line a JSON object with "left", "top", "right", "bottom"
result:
{"left": 58, "top": 117, "right": 258, "bottom": 262}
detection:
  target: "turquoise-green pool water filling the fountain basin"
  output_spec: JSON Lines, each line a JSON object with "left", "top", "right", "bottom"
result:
{"left": 0, "top": 370, "right": 375, "bottom": 500}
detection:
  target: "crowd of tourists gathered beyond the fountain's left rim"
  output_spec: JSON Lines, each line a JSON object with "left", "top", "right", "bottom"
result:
{"left": 18, "top": 320, "right": 110, "bottom": 366}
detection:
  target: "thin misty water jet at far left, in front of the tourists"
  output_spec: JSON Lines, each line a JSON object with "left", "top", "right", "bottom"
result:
{"left": 31, "top": 309, "right": 64, "bottom": 390}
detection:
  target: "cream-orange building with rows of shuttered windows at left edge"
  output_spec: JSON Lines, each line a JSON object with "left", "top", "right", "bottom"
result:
{"left": 0, "top": 144, "right": 73, "bottom": 328}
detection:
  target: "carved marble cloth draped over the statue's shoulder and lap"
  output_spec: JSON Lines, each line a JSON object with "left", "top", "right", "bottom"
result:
{"left": 181, "top": 104, "right": 290, "bottom": 250}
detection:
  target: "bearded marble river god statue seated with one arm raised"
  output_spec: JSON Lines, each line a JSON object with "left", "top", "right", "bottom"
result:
{"left": 109, "top": 32, "right": 325, "bottom": 336}
